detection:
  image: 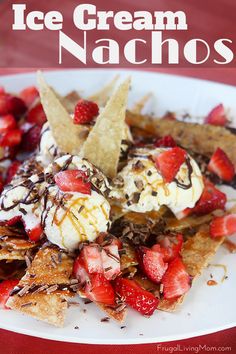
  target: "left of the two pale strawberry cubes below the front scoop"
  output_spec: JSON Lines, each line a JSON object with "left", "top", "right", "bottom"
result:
{"left": 80, "top": 244, "right": 103, "bottom": 274}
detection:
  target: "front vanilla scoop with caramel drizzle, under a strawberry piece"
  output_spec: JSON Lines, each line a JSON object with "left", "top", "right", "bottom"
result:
{"left": 41, "top": 155, "right": 110, "bottom": 251}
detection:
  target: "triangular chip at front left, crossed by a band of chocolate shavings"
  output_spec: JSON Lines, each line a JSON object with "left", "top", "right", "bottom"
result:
{"left": 7, "top": 247, "right": 73, "bottom": 327}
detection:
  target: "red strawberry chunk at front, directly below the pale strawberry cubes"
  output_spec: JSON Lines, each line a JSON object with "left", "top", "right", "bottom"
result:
{"left": 84, "top": 273, "right": 115, "bottom": 305}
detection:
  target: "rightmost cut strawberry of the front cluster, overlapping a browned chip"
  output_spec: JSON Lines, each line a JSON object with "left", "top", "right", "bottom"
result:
{"left": 162, "top": 257, "right": 190, "bottom": 299}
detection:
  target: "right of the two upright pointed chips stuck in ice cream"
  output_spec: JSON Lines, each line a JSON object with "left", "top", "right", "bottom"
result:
{"left": 81, "top": 79, "right": 130, "bottom": 178}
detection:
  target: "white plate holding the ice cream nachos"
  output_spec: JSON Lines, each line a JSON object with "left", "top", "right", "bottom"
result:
{"left": 0, "top": 70, "right": 236, "bottom": 344}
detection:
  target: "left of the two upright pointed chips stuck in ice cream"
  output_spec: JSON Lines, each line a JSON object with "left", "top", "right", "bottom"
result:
{"left": 37, "top": 72, "right": 87, "bottom": 154}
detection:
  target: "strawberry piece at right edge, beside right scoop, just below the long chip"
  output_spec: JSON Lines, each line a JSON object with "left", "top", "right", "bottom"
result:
{"left": 207, "top": 148, "right": 235, "bottom": 182}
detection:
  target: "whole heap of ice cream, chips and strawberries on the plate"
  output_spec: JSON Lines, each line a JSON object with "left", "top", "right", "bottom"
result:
{"left": 0, "top": 72, "right": 236, "bottom": 327}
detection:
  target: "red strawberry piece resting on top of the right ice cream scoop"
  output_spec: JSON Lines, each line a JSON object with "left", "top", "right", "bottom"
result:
{"left": 156, "top": 147, "right": 186, "bottom": 183}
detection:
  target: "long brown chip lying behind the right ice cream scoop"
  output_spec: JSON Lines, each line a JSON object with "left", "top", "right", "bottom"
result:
{"left": 126, "top": 111, "right": 236, "bottom": 164}
